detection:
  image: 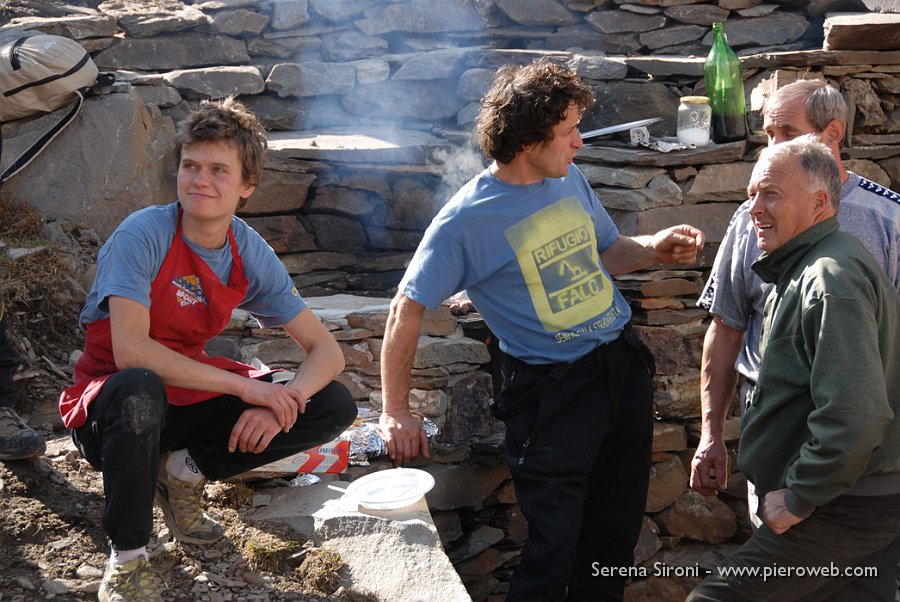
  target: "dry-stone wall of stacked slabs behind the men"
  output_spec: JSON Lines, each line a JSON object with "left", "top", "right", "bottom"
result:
{"left": 0, "top": 0, "right": 900, "bottom": 600}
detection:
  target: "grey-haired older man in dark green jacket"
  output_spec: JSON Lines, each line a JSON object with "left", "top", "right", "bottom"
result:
{"left": 688, "top": 137, "right": 900, "bottom": 602}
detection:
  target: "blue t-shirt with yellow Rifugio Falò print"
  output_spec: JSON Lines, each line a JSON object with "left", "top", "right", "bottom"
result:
{"left": 399, "top": 165, "right": 631, "bottom": 364}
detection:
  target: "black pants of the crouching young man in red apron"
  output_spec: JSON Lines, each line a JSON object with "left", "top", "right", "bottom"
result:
{"left": 72, "top": 369, "right": 356, "bottom": 550}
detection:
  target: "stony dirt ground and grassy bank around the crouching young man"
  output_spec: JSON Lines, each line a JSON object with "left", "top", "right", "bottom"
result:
{"left": 0, "top": 196, "right": 374, "bottom": 602}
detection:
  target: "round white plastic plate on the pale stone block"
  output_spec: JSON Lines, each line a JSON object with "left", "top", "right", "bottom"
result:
{"left": 346, "top": 468, "right": 434, "bottom": 510}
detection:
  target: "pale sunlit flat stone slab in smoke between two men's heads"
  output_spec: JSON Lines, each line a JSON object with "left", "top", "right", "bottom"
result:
{"left": 269, "top": 128, "right": 451, "bottom": 164}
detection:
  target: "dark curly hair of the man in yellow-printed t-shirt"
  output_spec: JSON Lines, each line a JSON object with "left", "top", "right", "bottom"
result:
{"left": 475, "top": 59, "right": 596, "bottom": 163}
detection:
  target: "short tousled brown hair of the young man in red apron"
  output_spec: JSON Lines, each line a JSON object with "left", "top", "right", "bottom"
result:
{"left": 174, "top": 97, "right": 268, "bottom": 208}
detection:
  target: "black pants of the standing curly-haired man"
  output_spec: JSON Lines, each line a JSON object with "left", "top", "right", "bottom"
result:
{"left": 498, "top": 331, "right": 654, "bottom": 602}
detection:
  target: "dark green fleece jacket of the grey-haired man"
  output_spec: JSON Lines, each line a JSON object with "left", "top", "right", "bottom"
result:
{"left": 738, "top": 218, "right": 900, "bottom": 517}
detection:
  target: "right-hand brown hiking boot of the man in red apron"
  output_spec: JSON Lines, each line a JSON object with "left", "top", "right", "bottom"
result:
{"left": 154, "top": 455, "right": 225, "bottom": 545}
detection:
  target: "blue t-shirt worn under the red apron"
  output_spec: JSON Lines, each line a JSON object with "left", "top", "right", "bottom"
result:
{"left": 80, "top": 203, "right": 306, "bottom": 328}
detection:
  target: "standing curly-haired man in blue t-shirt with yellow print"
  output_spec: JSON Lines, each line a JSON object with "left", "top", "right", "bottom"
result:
{"left": 381, "top": 60, "right": 703, "bottom": 602}
